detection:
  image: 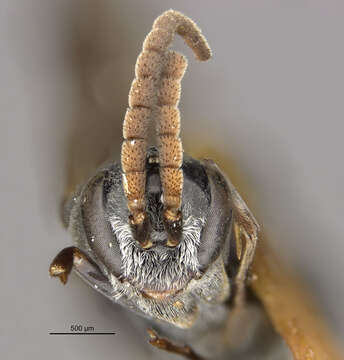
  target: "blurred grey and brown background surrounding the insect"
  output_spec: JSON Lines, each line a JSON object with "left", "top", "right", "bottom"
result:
{"left": 0, "top": 0, "right": 344, "bottom": 360}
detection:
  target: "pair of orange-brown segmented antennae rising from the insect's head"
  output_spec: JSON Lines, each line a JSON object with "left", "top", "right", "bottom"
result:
{"left": 121, "top": 10, "right": 211, "bottom": 246}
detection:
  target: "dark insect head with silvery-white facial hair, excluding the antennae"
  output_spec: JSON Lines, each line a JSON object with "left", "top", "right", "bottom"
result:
{"left": 74, "top": 148, "right": 231, "bottom": 327}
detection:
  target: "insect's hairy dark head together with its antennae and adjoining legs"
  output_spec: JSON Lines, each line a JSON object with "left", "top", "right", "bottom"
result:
{"left": 50, "top": 10, "right": 258, "bottom": 358}
